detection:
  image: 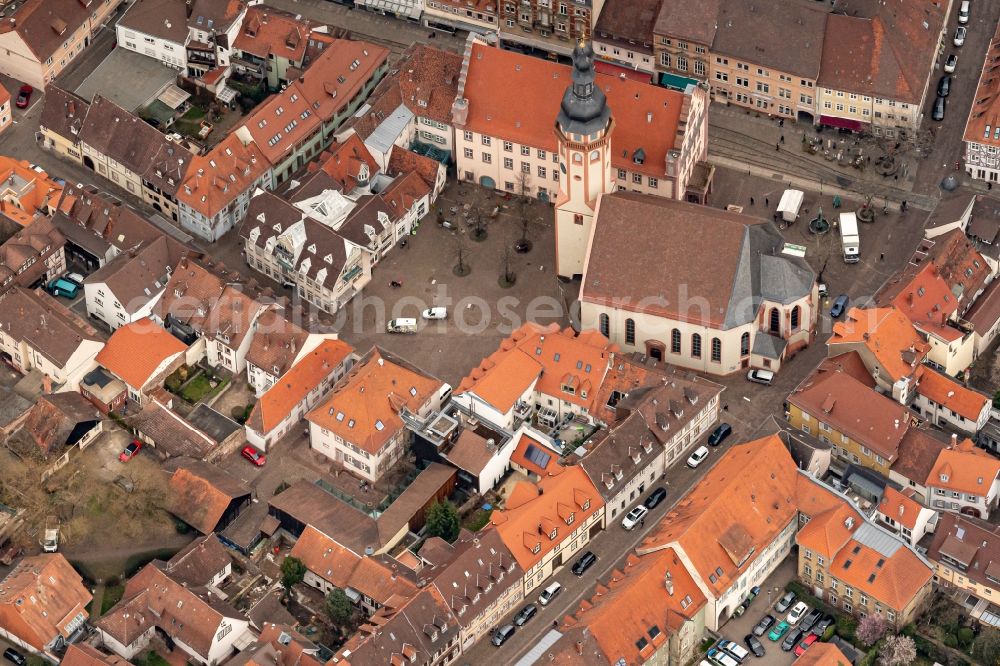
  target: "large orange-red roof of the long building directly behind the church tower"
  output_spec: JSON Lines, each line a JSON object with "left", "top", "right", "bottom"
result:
{"left": 461, "top": 40, "right": 689, "bottom": 178}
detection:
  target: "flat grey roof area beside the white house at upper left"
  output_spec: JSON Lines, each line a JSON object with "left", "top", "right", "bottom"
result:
{"left": 76, "top": 49, "right": 177, "bottom": 111}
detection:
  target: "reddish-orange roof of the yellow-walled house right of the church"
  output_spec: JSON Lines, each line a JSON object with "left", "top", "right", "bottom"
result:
{"left": 788, "top": 360, "right": 910, "bottom": 461}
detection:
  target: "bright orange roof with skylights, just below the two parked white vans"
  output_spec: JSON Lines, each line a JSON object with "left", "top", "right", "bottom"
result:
{"left": 306, "top": 347, "right": 444, "bottom": 454}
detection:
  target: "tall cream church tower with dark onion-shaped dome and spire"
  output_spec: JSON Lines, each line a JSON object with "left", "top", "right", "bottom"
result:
{"left": 555, "top": 41, "right": 615, "bottom": 278}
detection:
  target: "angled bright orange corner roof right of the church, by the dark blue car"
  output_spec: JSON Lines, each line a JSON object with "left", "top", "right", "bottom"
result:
{"left": 826, "top": 307, "right": 930, "bottom": 382}
